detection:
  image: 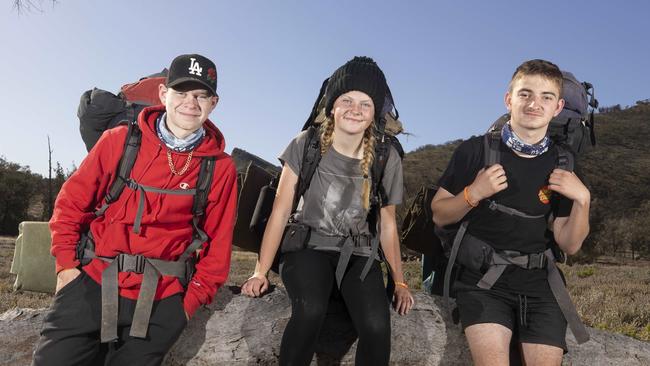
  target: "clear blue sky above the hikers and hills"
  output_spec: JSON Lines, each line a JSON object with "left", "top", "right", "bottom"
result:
{"left": 0, "top": 0, "right": 650, "bottom": 175}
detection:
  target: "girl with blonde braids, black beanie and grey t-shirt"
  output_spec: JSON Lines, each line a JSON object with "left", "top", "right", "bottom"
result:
{"left": 242, "top": 57, "right": 413, "bottom": 365}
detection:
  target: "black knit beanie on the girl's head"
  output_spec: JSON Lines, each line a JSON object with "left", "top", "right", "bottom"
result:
{"left": 325, "top": 56, "right": 388, "bottom": 121}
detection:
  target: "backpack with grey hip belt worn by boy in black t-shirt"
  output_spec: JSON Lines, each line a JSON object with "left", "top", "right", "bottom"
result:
{"left": 394, "top": 72, "right": 598, "bottom": 343}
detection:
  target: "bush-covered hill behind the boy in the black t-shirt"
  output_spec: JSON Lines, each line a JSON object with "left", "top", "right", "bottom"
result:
{"left": 401, "top": 102, "right": 650, "bottom": 257}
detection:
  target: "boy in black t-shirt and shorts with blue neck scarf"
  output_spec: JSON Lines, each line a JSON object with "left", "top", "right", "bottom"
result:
{"left": 431, "top": 60, "right": 590, "bottom": 365}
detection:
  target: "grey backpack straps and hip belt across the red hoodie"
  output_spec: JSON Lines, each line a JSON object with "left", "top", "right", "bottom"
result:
{"left": 76, "top": 121, "right": 216, "bottom": 343}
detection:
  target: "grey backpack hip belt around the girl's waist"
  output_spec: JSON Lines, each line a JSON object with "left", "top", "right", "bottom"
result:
{"left": 309, "top": 230, "right": 379, "bottom": 288}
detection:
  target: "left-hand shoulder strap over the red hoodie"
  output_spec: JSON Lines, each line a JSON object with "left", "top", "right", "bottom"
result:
{"left": 95, "top": 121, "right": 142, "bottom": 216}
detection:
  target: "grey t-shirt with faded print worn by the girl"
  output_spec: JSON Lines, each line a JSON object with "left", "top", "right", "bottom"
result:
{"left": 279, "top": 131, "right": 404, "bottom": 236}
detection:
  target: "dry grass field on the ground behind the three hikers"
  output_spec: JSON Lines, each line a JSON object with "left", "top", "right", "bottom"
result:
{"left": 0, "top": 237, "right": 650, "bottom": 342}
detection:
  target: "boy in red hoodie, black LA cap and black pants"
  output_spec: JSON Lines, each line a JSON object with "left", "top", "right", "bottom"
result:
{"left": 33, "top": 54, "right": 237, "bottom": 365}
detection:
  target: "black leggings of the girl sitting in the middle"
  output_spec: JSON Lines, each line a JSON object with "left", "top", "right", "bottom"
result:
{"left": 280, "top": 249, "right": 390, "bottom": 366}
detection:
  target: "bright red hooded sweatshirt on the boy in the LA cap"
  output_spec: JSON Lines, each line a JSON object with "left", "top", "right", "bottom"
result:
{"left": 50, "top": 106, "right": 237, "bottom": 316}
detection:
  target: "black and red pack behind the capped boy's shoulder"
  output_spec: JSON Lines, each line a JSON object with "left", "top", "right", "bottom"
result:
{"left": 77, "top": 69, "right": 167, "bottom": 151}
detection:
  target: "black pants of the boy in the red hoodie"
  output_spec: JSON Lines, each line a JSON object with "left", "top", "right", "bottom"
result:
{"left": 32, "top": 271, "right": 187, "bottom": 366}
